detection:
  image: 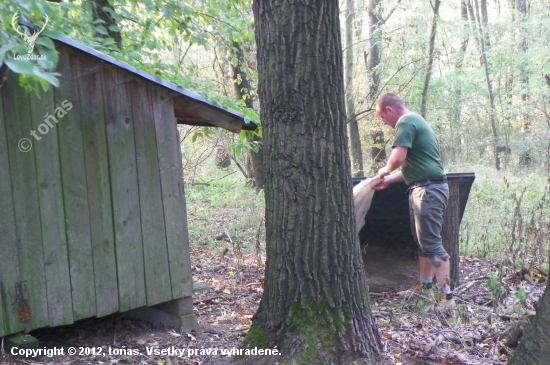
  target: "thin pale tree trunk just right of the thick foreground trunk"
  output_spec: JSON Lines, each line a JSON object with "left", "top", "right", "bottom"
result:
{"left": 344, "top": 0, "right": 364, "bottom": 177}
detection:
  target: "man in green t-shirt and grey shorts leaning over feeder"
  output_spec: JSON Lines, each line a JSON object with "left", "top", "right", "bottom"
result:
{"left": 373, "top": 94, "right": 455, "bottom": 308}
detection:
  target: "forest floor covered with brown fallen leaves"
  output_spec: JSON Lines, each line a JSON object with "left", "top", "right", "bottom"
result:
{"left": 0, "top": 248, "right": 546, "bottom": 365}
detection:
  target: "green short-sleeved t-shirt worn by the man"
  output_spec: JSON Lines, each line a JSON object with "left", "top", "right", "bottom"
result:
{"left": 393, "top": 113, "right": 446, "bottom": 185}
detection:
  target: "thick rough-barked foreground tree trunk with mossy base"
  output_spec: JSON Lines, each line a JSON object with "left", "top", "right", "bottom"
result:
{"left": 240, "top": 0, "right": 382, "bottom": 365}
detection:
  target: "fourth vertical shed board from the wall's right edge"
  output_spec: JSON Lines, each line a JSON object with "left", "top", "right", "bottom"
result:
{"left": 75, "top": 53, "right": 118, "bottom": 317}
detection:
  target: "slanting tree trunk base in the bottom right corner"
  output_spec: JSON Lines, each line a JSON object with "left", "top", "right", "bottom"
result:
{"left": 508, "top": 283, "right": 550, "bottom": 365}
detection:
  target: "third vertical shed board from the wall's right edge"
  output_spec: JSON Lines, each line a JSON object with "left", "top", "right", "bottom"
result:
{"left": 103, "top": 66, "right": 147, "bottom": 311}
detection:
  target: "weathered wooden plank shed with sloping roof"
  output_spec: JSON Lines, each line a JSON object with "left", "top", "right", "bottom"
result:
{"left": 0, "top": 38, "right": 254, "bottom": 336}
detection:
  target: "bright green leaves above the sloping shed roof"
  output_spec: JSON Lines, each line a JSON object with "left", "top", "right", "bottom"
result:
{"left": 0, "top": 0, "right": 259, "bottom": 135}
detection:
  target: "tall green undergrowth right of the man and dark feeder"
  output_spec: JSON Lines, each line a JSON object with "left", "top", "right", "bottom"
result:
{"left": 462, "top": 166, "right": 550, "bottom": 267}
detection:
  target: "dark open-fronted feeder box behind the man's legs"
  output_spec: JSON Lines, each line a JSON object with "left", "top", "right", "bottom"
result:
{"left": 353, "top": 172, "right": 475, "bottom": 291}
